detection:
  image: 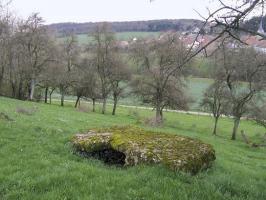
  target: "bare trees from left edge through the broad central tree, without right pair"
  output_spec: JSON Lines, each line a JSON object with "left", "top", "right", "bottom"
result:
{"left": 0, "top": 7, "right": 191, "bottom": 119}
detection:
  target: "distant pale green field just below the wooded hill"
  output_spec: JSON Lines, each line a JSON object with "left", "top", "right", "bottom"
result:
{"left": 59, "top": 32, "right": 160, "bottom": 45}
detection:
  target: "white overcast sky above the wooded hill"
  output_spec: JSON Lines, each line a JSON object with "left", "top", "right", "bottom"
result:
{"left": 12, "top": 0, "right": 218, "bottom": 24}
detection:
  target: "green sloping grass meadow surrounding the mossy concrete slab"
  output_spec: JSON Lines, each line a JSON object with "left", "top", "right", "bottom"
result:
{"left": 0, "top": 98, "right": 266, "bottom": 200}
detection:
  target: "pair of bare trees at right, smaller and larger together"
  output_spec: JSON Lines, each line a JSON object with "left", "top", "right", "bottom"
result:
{"left": 201, "top": 43, "right": 266, "bottom": 140}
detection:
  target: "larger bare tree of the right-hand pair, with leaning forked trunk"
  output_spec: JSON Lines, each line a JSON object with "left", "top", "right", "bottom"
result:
{"left": 214, "top": 46, "right": 266, "bottom": 140}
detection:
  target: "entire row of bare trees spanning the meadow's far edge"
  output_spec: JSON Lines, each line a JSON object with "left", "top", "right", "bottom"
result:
{"left": 0, "top": 0, "right": 266, "bottom": 139}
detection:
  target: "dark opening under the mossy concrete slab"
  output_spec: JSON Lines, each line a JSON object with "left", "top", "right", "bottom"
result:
{"left": 80, "top": 148, "right": 126, "bottom": 167}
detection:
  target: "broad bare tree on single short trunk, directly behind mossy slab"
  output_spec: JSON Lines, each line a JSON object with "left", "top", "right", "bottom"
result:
{"left": 132, "top": 33, "right": 187, "bottom": 123}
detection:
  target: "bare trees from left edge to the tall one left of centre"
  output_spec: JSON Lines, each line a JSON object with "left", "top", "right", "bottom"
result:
{"left": 0, "top": 11, "right": 130, "bottom": 114}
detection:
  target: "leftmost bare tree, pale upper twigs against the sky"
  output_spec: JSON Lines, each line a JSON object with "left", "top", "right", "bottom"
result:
{"left": 0, "top": 18, "right": 31, "bottom": 99}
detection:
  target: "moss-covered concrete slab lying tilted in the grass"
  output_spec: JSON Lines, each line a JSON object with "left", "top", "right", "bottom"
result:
{"left": 72, "top": 126, "right": 215, "bottom": 174}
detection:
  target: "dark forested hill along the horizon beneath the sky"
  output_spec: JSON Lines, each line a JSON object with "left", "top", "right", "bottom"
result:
{"left": 49, "top": 19, "right": 203, "bottom": 35}
